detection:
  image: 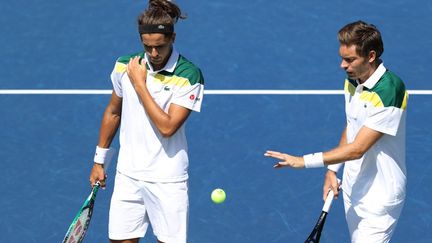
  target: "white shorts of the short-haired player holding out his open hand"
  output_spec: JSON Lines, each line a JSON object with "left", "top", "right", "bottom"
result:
{"left": 343, "top": 193, "right": 404, "bottom": 243}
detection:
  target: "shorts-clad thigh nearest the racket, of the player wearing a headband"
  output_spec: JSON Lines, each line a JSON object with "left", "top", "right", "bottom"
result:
{"left": 109, "top": 173, "right": 149, "bottom": 242}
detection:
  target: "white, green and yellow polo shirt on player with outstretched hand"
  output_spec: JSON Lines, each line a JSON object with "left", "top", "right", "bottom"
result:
{"left": 342, "top": 64, "right": 408, "bottom": 205}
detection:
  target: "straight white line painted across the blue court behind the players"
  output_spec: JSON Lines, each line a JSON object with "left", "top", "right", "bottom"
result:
{"left": 0, "top": 89, "right": 432, "bottom": 95}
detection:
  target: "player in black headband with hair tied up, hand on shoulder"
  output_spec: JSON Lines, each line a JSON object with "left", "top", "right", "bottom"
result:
{"left": 90, "top": 0, "right": 204, "bottom": 243}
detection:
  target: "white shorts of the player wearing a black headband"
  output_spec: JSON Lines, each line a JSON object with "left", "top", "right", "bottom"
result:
{"left": 109, "top": 172, "right": 189, "bottom": 243}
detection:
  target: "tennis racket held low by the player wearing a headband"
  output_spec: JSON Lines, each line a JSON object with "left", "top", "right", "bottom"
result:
{"left": 63, "top": 182, "right": 100, "bottom": 243}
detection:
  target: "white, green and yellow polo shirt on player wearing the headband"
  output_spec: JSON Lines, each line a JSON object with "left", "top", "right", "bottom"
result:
{"left": 111, "top": 50, "right": 204, "bottom": 182}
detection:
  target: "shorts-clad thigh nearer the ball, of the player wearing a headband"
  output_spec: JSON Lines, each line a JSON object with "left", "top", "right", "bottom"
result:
{"left": 144, "top": 181, "right": 189, "bottom": 242}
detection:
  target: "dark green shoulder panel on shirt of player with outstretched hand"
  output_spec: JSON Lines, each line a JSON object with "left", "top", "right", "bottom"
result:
{"left": 368, "top": 70, "right": 408, "bottom": 109}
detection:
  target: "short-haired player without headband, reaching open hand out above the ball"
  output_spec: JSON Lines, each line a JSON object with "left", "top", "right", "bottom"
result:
{"left": 265, "top": 21, "right": 408, "bottom": 243}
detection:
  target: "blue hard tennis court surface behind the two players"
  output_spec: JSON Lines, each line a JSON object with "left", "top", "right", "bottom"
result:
{"left": 0, "top": 0, "right": 432, "bottom": 243}
